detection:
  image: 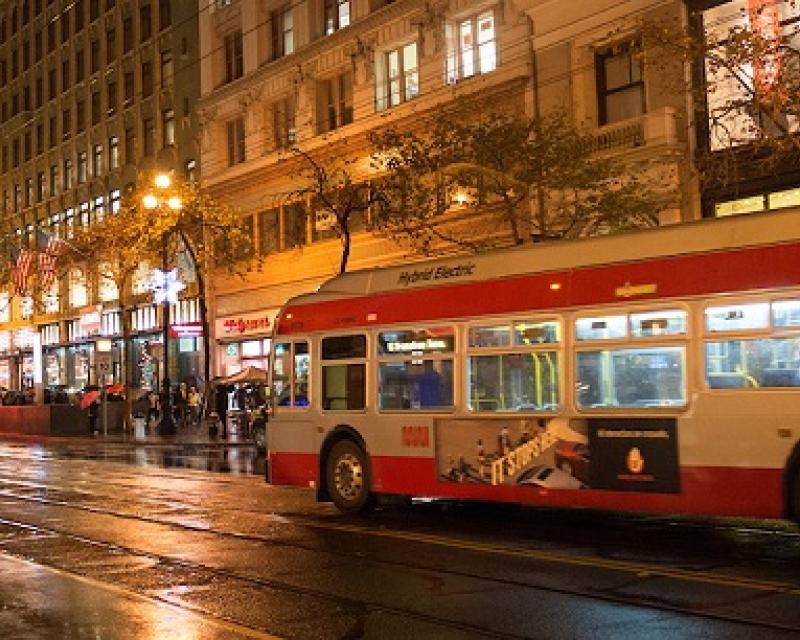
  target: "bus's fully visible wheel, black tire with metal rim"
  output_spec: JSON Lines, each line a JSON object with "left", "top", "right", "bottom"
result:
{"left": 325, "top": 440, "right": 374, "bottom": 513}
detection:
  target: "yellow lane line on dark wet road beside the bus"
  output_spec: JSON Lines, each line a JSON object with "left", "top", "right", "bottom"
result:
{"left": 294, "top": 518, "right": 800, "bottom": 596}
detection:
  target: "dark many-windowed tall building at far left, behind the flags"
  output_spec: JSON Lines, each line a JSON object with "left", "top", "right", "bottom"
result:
{"left": 0, "top": 0, "right": 200, "bottom": 396}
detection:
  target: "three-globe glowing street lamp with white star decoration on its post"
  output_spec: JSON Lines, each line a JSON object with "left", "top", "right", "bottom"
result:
{"left": 142, "top": 173, "right": 186, "bottom": 435}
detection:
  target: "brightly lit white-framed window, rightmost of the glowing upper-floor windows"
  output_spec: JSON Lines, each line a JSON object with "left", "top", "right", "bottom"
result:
{"left": 445, "top": 10, "right": 497, "bottom": 84}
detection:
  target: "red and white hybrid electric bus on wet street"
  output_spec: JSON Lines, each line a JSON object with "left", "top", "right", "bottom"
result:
{"left": 268, "top": 211, "right": 800, "bottom": 518}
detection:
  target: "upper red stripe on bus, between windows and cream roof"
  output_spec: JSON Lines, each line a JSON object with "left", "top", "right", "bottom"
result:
{"left": 278, "top": 244, "right": 800, "bottom": 334}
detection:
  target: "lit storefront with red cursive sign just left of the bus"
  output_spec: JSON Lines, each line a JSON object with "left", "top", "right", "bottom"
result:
{"left": 215, "top": 309, "right": 278, "bottom": 376}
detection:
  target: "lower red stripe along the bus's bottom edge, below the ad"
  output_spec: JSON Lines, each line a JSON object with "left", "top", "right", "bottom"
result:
{"left": 270, "top": 453, "right": 783, "bottom": 518}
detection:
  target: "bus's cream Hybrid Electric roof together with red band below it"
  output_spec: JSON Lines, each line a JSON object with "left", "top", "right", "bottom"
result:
{"left": 277, "top": 210, "right": 800, "bottom": 334}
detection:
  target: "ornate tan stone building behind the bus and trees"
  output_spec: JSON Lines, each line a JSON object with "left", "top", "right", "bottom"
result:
{"left": 199, "top": 0, "right": 697, "bottom": 380}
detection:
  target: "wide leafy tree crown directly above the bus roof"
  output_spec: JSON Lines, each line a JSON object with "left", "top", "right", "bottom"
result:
{"left": 372, "top": 113, "right": 658, "bottom": 252}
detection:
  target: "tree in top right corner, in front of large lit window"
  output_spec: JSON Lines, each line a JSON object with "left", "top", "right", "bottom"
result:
{"left": 640, "top": 0, "right": 800, "bottom": 187}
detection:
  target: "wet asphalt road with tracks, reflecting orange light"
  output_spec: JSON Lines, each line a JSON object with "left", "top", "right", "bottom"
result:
{"left": 0, "top": 441, "right": 800, "bottom": 640}
